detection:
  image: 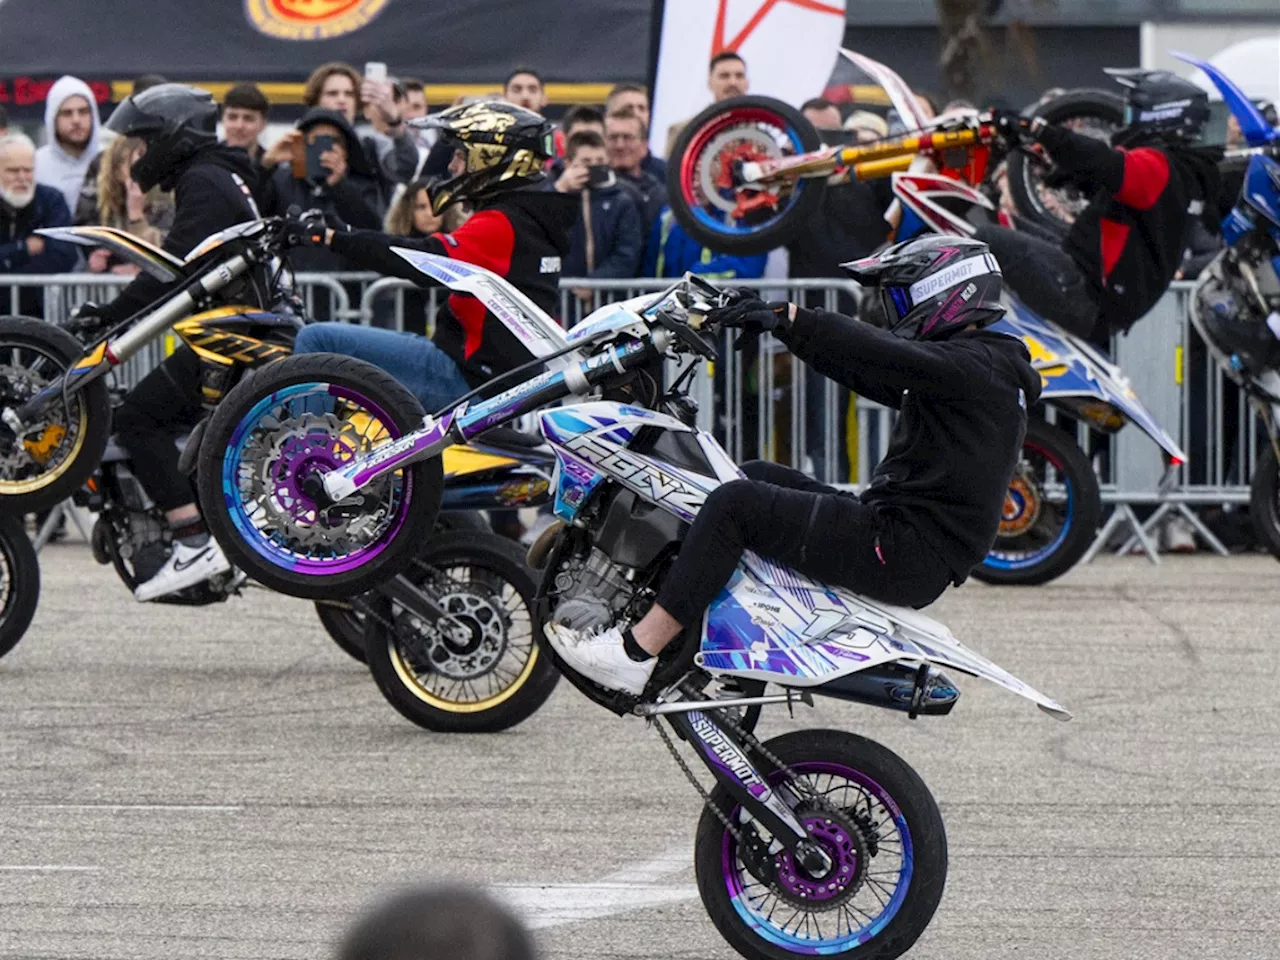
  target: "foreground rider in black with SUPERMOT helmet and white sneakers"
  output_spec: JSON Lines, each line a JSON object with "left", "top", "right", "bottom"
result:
{"left": 545, "top": 237, "right": 1041, "bottom": 694}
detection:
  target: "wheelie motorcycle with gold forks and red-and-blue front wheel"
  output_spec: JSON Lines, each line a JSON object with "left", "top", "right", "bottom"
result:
{"left": 668, "top": 51, "right": 1187, "bottom": 584}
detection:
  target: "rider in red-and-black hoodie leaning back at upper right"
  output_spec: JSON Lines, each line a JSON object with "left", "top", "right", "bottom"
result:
{"left": 977, "top": 69, "right": 1221, "bottom": 343}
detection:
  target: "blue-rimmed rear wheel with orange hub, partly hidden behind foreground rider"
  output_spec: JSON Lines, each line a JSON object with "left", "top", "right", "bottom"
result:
{"left": 973, "top": 420, "right": 1102, "bottom": 586}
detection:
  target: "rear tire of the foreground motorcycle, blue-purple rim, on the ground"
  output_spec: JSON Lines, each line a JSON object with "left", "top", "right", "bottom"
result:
{"left": 694, "top": 730, "right": 947, "bottom": 960}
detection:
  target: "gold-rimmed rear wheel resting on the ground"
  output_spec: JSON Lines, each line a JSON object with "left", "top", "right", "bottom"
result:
{"left": 365, "top": 534, "right": 559, "bottom": 733}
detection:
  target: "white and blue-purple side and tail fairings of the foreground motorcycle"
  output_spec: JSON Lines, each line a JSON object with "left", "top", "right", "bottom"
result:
{"left": 540, "top": 401, "right": 1071, "bottom": 719}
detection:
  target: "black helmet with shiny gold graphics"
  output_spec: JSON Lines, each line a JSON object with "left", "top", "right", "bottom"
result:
{"left": 413, "top": 100, "right": 556, "bottom": 215}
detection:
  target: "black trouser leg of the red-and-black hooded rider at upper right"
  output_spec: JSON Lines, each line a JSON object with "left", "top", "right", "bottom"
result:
{"left": 975, "top": 227, "right": 1098, "bottom": 337}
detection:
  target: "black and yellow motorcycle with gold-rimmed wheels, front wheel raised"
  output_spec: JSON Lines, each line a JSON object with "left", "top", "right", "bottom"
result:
{"left": 0, "top": 219, "right": 557, "bottom": 730}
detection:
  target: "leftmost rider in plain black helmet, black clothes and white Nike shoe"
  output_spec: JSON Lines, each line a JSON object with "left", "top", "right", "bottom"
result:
{"left": 78, "top": 83, "right": 259, "bottom": 600}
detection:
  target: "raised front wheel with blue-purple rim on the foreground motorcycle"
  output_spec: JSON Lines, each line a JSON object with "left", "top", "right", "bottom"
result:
{"left": 197, "top": 353, "right": 444, "bottom": 600}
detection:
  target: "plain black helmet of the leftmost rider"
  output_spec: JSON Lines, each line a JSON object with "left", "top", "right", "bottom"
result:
{"left": 106, "top": 83, "right": 218, "bottom": 191}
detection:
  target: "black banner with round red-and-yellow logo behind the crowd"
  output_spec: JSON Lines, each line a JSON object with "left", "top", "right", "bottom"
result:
{"left": 0, "top": 0, "right": 653, "bottom": 113}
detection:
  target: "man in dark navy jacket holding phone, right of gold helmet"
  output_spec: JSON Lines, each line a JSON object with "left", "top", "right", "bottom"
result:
{"left": 556, "top": 131, "right": 644, "bottom": 303}
